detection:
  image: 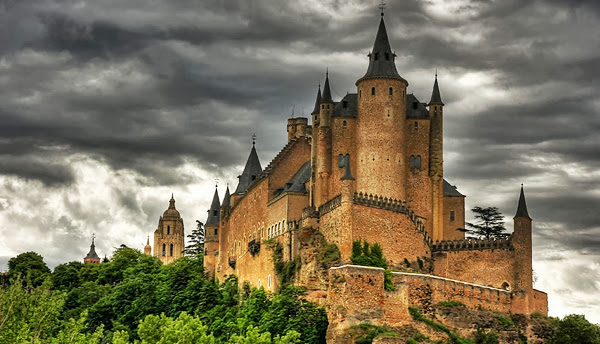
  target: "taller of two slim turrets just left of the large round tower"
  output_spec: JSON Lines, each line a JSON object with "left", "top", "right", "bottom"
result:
{"left": 313, "top": 71, "right": 334, "bottom": 207}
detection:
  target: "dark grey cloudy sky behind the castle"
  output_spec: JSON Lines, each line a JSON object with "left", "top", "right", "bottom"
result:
{"left": 0, "top": 0, "right": 600, "bottom": 323}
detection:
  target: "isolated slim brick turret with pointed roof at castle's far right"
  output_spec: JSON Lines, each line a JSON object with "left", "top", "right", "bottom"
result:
{"left": 512, "top": 185, "right": 534, "bottom": 314}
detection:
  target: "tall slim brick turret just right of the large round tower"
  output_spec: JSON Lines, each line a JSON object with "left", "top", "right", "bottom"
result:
{"left": 428, "top": 72, "right": 444, "bottom": 242}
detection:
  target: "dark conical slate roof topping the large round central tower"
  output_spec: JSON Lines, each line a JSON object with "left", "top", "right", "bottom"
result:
{"left": 359, "top": 16, "right": 404, "bottom": 81}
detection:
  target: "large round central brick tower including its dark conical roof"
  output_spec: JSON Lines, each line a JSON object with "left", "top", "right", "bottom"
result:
{"left": 351, "top": 14, "right": 408, "bottom": 200}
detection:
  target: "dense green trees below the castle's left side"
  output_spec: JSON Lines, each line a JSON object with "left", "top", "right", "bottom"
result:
{"left": 0, "top": 246, "right": 328, "bottom": 344}
